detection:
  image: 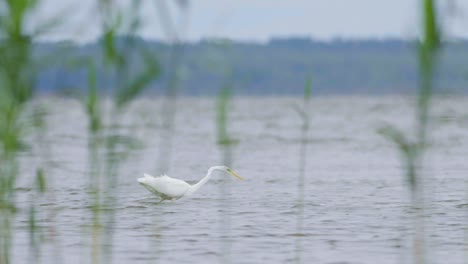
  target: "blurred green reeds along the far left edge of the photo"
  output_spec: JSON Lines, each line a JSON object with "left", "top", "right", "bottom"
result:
{"left": 0, "top": 0, "right": 35, "bottom": 264}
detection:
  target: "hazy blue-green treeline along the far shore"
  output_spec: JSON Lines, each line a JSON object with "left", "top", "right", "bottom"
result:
{"left": 35, "top": 37, "right": 468, "bottom": 95}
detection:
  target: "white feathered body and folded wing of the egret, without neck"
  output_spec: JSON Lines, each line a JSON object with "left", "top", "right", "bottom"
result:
{"left": 138, "top": 174, "right": 190, "bottom": 198}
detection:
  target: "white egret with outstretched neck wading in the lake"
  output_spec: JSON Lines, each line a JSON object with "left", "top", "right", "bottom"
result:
{"left": 138, "top": 166, "right": 243, "bottom": 202}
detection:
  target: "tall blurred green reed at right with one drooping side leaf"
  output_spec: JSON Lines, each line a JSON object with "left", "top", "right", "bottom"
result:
{"left": 379, "top": 0, "right": 440, "bottom": 264}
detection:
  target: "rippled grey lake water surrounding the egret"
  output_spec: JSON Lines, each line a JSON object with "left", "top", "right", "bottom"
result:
{"left": 12, "top": 97, "right": 468, "bottom": 264}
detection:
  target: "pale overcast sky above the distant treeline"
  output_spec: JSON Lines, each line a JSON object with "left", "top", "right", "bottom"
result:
{"left": 31, "top": 0, "right": 468, "bottom": 41}
